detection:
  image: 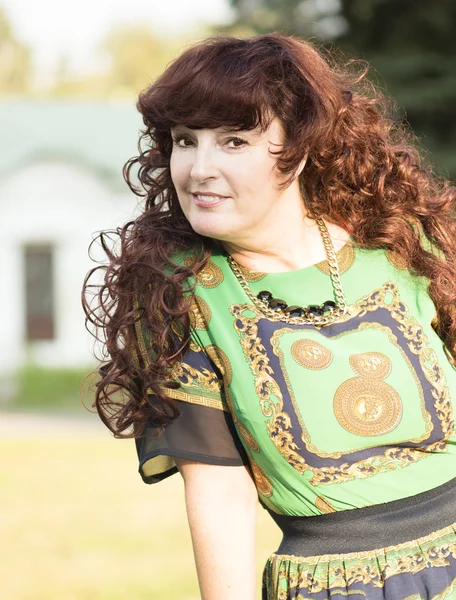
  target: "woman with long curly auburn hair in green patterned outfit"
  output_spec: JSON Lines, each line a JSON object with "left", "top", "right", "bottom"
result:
{"left": 84, "top": 34, "right": 456, "bottom": 600}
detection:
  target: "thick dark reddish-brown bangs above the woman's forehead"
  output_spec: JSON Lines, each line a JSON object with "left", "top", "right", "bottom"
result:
{"left": 144, "top": 38, "right": 275, "bottom": 132}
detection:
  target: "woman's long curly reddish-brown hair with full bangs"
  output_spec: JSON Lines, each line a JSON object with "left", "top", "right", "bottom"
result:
{"left": 82, "top": 33, "right": 456, "bottom": 437}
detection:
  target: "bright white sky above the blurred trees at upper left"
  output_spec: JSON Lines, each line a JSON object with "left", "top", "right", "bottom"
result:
{"left": 0, "top": 0, "right": 230, "bottom": 82}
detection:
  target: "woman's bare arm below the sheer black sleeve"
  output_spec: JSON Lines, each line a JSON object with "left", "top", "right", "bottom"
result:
{"left": 175, "top": 458, "right": 258, "bottom": 600}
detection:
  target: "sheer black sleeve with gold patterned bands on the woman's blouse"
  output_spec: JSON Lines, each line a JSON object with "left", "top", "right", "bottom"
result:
{"left": 135, "top": 292, "right": 248, "bottom": 483}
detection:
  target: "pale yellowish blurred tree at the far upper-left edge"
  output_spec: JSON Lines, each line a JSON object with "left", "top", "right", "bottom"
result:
{"left": 0, "top": 7, "right": 31, "bottom": 94}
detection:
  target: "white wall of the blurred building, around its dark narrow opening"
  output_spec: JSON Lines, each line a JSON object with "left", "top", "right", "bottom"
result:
{"left": 0, "top": 161, "right": 138, "bottom": 377}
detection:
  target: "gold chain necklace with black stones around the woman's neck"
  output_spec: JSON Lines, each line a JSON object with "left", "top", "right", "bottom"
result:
{"left": 227, "top": 219, "right": 347, "bottom": 325}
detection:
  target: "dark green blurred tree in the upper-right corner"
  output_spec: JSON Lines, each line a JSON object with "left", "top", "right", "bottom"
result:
{"left": 337, "top": 0, "right": 456, "bottom": 177}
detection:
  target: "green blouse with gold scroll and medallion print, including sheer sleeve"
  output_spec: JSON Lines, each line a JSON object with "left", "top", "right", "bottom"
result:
{"left": 137, "top": 241, "right": 456, "bottom": 516}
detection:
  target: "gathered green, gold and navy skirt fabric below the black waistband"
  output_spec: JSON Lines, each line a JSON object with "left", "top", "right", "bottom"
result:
{"left": 263, "top": 524, "right": 456, "bottom": 600}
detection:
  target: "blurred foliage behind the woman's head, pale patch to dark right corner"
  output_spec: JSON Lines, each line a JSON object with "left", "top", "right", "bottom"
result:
{"left": 223, "top": 0, "right": 456, "bottom": 177}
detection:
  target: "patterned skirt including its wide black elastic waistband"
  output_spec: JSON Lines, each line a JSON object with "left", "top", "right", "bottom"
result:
{"left": 262, "top": 478, "right": 456, "bottom": 600}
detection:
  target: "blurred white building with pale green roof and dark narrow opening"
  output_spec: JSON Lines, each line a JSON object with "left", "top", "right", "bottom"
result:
{"left": 0, "top": 98, "right": 142, "bottom": 391}
